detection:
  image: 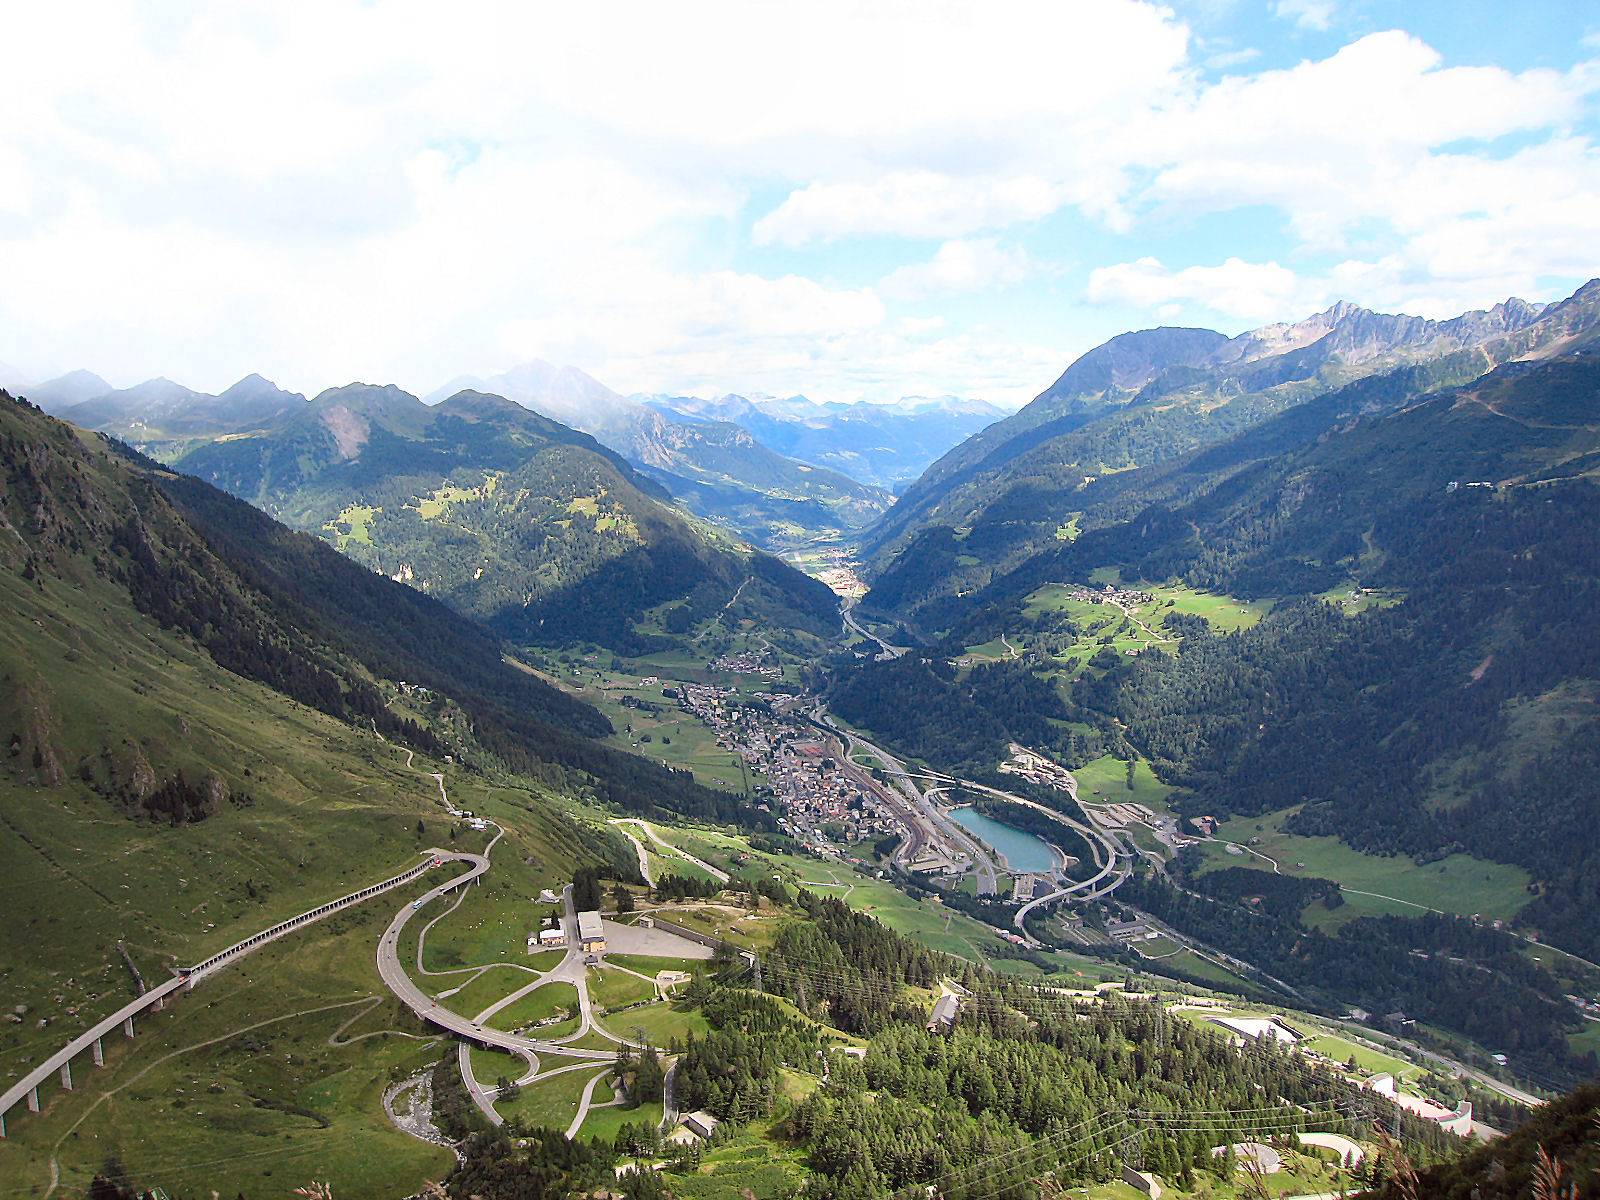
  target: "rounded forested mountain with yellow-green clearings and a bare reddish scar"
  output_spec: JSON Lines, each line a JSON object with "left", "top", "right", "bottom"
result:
{"left": 150, "top": 384, "right": 834, "bottom": 651}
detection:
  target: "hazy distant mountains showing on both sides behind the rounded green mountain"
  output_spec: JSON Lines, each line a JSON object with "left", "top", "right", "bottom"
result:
{"left": 13, "top": 360, "right": 1002, "bottom": 552}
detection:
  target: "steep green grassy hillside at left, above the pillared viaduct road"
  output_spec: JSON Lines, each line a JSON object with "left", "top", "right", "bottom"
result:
{"left": 0, "top": 573, "right": 544, "bottom": 1069}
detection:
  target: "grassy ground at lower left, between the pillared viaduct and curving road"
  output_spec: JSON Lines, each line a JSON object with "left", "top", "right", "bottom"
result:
{"left": 0, "top": 883, "right": 454, "bottom": 1195}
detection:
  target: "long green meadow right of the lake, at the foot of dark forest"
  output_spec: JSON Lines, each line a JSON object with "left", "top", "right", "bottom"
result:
{"left": 1202, "top": 810, "right": 1531, "bottom": 926}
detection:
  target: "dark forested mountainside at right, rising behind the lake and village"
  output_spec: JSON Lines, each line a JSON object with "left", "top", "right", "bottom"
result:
{"left": 842, "top": 340, "right": 1600, "bottom": 957}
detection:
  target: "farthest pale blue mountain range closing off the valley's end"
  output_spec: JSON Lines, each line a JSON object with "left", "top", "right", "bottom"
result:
{"left": 643, "top": 395, "right": 1005, "bottom": 491}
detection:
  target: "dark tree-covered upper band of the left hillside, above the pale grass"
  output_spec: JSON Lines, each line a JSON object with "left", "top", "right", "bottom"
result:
{"left": 0, "top": 397, "right": 761, "bottom": 814}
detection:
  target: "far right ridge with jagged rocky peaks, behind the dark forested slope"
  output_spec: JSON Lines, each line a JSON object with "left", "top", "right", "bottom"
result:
{"left": 864, "top": 291, "right": 1560, "bottom": 606}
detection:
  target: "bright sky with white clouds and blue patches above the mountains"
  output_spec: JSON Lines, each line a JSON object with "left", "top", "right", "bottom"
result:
{"left": 0, "top": 0, "right": 1600, "bottom": 406}
